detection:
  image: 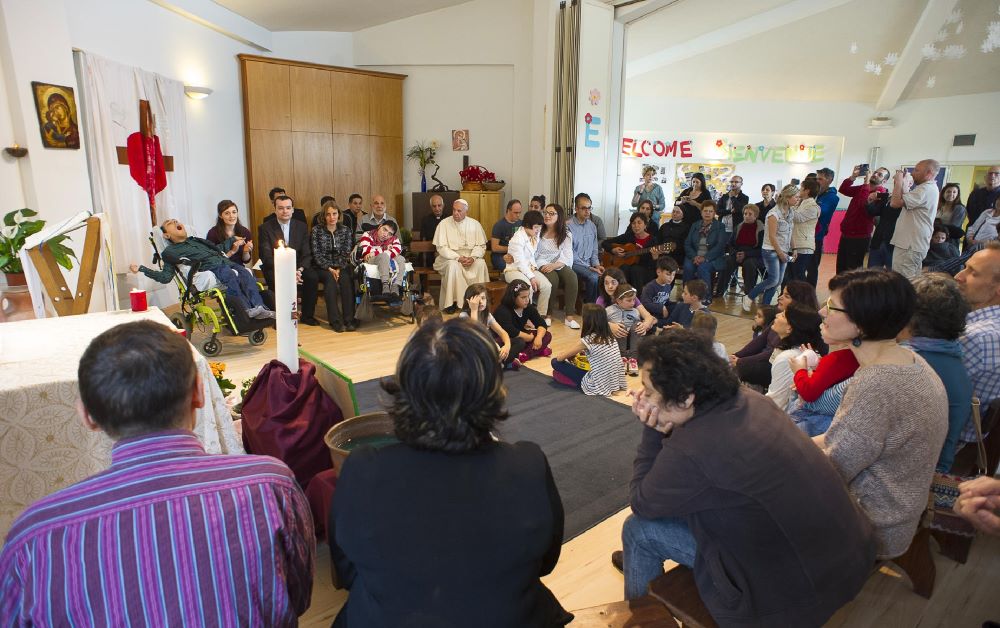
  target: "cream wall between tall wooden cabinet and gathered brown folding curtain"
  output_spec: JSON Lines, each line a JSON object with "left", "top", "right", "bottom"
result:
{"left": 354, "top": 0, "right": 554, "bottom": 226}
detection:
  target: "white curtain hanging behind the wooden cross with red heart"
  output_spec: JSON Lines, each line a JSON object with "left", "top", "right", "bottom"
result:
{"left": 75, "top": 52, "right": 192, "bottom": 306}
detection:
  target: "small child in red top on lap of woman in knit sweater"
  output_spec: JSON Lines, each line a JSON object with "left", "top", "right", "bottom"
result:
{"left": 788, "top": 344, "right": 858, "bottom": 436}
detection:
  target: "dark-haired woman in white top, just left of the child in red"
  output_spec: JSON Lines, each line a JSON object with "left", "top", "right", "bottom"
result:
{"left": 767, "top": 301, "right": 826, "bottom": 412}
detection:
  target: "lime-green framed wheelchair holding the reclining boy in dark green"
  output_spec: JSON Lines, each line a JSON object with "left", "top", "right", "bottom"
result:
{"left": 149, "top": 233, "right": 274, "bottom": 357}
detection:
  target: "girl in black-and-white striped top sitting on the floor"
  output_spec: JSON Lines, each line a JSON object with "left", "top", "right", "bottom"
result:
{"left": 552, "top": 303, "right": 628, "bottom": 395}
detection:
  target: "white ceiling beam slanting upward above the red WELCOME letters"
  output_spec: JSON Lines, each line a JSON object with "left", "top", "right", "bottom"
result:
{"left": 626, "top": 0, "right": 852, "bottom": 78}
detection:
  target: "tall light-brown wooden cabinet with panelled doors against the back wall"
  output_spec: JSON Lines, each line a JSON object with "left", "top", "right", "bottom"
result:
{"left": 239, "top": 55, "right": 406, "bottom": 230}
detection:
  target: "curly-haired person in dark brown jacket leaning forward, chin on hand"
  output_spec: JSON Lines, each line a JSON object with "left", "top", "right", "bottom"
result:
{"left": 616, "top": 330, "right": 876, "bottom": 626}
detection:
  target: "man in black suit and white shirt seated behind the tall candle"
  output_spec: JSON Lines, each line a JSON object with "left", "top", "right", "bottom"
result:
{"left": 257, "top": 194, "right": 319, "bottom": 325}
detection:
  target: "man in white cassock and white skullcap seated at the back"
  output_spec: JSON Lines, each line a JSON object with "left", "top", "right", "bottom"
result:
{"left": 434, "top": 199, "right": 490, "bottom": 309}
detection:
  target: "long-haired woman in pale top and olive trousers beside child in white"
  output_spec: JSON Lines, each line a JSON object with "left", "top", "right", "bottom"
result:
{"left": 535, "top": 203, "right": 580, "bottom": 329}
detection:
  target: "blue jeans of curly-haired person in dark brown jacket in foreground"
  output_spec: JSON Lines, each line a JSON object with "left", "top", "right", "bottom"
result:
{"left": 622, "top": 515, "right": 698, "bottom": 600}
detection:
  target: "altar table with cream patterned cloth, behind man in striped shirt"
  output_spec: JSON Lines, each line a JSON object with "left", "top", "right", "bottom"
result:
{"left": 0, "top": 308, "right": 245, "bottom": 542}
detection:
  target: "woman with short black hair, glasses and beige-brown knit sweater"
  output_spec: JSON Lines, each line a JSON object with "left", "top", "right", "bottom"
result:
{"left": 813, "top": 268, "right": 948, "bottom": 558}
